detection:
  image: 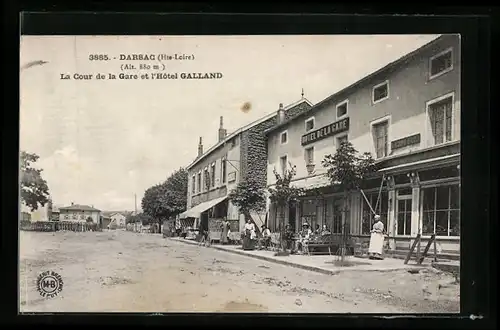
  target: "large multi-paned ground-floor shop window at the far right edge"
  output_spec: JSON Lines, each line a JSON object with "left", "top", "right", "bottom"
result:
{"left": 422, "top": 184, "right": 460, "bottom": 236}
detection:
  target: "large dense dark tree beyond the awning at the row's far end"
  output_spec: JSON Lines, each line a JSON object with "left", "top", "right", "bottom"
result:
{"left": 141, "top": 168, "right": 188, "bottom": 232}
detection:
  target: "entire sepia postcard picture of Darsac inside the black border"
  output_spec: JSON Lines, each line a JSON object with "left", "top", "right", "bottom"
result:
{"left": 18, "top": 34, "right": 466, "bottom": 314}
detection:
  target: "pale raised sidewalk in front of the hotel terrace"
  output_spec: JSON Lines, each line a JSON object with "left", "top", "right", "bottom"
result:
{"left": 168, "top": 237, "right": 431, "bottom": 275}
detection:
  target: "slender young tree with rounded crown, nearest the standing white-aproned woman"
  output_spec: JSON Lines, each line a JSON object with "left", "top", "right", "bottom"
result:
{"left": 322, "top": 141, "right": 375, "bottom": 261}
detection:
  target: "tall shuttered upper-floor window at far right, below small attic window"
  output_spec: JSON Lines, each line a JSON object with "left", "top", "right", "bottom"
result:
{"left": 428, "top": 95, "right": 453, "bottom": 144}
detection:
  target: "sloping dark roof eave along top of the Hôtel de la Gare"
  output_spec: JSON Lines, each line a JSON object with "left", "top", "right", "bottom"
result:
{"left": 266, "top": 35, "right": 446, "bottom": 134}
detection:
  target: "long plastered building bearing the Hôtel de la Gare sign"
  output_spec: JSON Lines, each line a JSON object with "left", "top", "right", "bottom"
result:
{"left": 266, "top": 35, "right": 461, "bottom": 257}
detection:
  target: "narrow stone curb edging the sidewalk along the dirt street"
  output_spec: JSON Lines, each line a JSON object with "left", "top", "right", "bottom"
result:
{"left": 171, "top": 239, "right": 426, "bottom": 275}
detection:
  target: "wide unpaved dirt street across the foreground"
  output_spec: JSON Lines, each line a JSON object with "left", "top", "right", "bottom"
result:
{"left": 20, "top": 231, "right": 459, "bottom": 313}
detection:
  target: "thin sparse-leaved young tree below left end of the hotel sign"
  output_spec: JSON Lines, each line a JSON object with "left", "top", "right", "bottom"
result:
{"left": 268, "top": 163, "right": 304, "bottom": 252}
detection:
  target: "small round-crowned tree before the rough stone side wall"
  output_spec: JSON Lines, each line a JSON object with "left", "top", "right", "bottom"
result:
{"left": 229, "top": 178, "right": 266, "bottom": 232}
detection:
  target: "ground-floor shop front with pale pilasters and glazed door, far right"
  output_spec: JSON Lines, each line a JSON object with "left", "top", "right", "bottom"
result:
{"left": 384, "top": 157, "right": 460, "bottom": 254}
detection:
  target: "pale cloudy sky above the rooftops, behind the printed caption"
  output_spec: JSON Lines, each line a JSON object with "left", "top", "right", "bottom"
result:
{"left": 20, "top": 35, "right": 437, "bottom": 210}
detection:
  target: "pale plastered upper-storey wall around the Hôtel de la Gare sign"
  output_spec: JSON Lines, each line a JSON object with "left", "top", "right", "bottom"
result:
{"left": 267, "top": 36, "right": 461, "bottom": 184}
